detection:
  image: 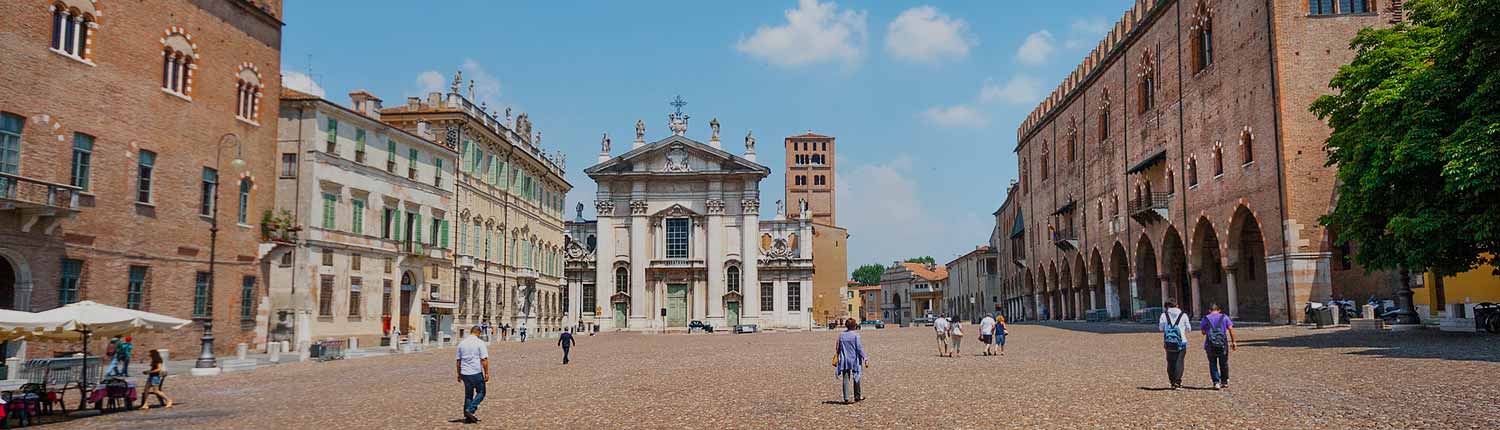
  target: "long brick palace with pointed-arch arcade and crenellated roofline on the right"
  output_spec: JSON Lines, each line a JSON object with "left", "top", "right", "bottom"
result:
{"left": 1002, "top": 0, "right": 1401, "bottom": 322}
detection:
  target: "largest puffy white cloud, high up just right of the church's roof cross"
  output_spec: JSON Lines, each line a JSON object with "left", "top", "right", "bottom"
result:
{"left": 735, "top": 0, "right": 869, "bottom": 67}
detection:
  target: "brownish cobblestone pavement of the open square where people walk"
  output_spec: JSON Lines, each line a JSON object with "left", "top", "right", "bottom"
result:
{"left": 67, "top": 322, "right": 1500, "bottom": 429}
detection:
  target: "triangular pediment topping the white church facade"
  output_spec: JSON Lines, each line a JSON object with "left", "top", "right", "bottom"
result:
{"left": 584, "top": 135, "right": 771, "bottom": 177}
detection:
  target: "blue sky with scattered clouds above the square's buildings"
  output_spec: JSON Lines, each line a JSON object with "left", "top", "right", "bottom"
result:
{"left": 282, "top": 0, "right": 1131, "bottom": 274}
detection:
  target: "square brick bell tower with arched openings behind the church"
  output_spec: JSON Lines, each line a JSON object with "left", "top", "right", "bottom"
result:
{"left": 786, "top": 130, "right": 839, "bottom": 226}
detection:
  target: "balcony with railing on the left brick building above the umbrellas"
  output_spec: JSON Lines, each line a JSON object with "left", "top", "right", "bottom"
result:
{"left": 0, "top": 172, "right": 83, "bottom": 234}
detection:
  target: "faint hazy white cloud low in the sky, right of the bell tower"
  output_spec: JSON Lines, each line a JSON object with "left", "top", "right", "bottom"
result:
{"left": 837, "top": 154, "right": 995, "bottom": 267}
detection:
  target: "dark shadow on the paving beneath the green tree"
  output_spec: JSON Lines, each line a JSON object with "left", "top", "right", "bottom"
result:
{"left": 1239, "top": 330, "right": 1500, "bottom": 363}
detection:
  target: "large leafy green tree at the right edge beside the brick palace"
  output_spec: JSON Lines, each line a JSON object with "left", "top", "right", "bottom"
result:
{"left": 1311, "top": 0, "right": 1500, "bottom": 274}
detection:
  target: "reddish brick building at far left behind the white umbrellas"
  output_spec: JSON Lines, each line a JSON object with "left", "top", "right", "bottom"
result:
{"left": 0, "top": 0, "right": 282, "bottom": 357}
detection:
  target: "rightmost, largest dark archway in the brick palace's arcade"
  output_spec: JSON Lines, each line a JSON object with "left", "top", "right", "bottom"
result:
{"left": 1224, "top": 205, "right": 1271, "bottom": 322}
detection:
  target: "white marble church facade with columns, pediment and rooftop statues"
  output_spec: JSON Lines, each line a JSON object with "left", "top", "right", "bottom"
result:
{"left": 569, "top": 126, "right": 813, "bottom": 331}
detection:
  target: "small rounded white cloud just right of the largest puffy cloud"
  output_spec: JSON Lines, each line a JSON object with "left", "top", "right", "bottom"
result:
{"left": 885, "top": 6, "right": 978, "bottom": 63}
